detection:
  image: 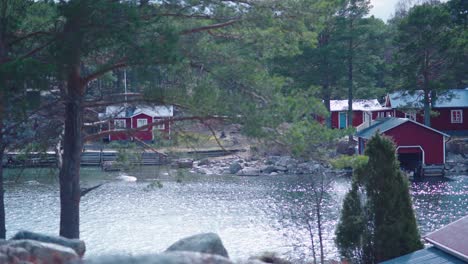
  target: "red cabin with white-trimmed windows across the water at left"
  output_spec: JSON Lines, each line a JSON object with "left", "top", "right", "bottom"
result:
{"left": 99, "top": 106, "right": 174, "bottom": 141}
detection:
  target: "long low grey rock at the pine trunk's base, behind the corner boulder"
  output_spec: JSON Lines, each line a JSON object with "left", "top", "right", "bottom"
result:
{"left": 10, "top": 231, "right": 86, "bottom": 257}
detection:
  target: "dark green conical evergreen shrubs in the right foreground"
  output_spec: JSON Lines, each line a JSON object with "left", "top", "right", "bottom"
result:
{"left": 336, "top": 134, "right": 423, "bottom": 263}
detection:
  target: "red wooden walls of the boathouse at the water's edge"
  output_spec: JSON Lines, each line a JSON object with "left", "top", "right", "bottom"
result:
{"left": 384, "top": 122, "right": 445, "bottom": 165}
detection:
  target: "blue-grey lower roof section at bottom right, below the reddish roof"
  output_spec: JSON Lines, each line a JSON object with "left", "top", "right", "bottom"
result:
{"left": 381, "top": 247, "right": 466, "bottom": 264}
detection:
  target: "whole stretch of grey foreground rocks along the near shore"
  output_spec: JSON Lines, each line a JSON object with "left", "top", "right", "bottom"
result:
{"left": 0, "top": 231, "right": 290, "bottom": 264}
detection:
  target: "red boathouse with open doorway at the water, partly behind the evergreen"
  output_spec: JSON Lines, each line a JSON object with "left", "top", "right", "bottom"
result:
{"left": 356, "top": 117, "right": 449, "bottom": 175}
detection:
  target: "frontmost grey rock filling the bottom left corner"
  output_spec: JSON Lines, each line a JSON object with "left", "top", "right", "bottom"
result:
{"left": 0, "top": 240, "right": 80, "bottom": 264}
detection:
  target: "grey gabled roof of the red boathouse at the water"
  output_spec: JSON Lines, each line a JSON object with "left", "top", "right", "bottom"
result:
{"left": 356, "top": 117, "right": 449, "bottom": 139}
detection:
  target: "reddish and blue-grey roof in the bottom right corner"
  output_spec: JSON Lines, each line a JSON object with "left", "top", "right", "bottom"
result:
{"left": 382, "top": 215, "right": 468, "bottom": 264}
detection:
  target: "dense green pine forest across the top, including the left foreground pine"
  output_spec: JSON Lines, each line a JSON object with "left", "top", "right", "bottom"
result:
{"left": 0, "top": 0, "right": 468, "bottom": 258}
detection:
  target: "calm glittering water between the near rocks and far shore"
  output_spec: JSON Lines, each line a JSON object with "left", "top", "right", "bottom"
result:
{"left": 5, "top": 167, "right": 468, "bottom": 259}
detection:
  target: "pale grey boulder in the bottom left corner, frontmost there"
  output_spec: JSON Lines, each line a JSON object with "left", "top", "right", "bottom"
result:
{"left": 7, "top": 240, "right": 80, "bottom": 264}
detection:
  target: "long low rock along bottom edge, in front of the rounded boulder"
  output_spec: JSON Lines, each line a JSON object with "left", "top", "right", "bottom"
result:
{"left": 72, "top": 251, "right": 234, "bottom": 264}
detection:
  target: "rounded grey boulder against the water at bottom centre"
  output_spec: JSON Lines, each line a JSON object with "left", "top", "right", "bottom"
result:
{"left": 166, "top": 233, "right": 229, "bottom": 258}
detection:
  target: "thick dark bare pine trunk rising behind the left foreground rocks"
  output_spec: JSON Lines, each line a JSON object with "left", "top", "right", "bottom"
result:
{"left": 60, "top": 75, "right": 83, "bottom": 238}
